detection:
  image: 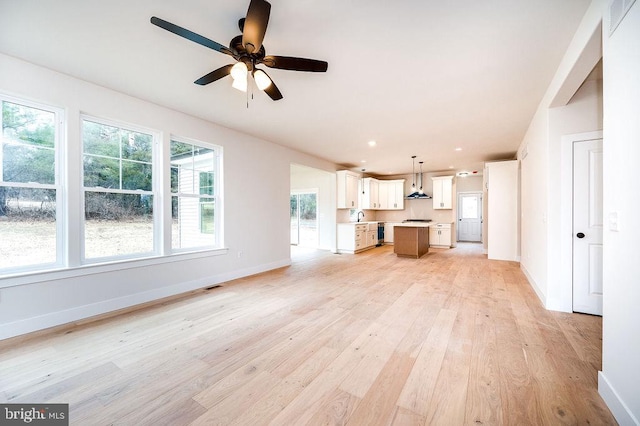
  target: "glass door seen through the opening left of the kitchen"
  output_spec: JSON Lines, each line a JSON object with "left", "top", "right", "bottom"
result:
{"left": 289, "top": 191, "right": 318, "bottom": 248}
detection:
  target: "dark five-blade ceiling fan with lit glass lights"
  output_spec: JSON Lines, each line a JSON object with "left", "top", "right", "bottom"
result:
{"left": 151, "top": 0, "right": 328, "bottom": 101}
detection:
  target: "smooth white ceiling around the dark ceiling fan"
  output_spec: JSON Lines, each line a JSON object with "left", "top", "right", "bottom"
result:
{"left": 0, "top": 0, "right": 590, "bottom": 175}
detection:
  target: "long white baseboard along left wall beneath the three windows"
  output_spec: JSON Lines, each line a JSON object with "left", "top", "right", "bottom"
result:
{"left": 0, "top": 259, "right": 291, "bottom": 340}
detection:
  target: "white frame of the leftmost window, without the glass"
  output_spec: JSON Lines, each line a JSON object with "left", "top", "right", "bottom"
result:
{"left": 0, "top": 92, "right": 68, "bottom": 274}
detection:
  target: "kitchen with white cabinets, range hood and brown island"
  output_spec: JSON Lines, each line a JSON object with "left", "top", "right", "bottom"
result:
{"left": 337, "top": 170, "right": 456, "bottom": 259}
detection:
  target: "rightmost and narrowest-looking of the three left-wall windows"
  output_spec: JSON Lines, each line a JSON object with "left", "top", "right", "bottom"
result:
{"left": 171, "top": 138, "right": 219, "bottom": 250}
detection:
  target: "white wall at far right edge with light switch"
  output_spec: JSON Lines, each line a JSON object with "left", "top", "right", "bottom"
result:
{"left": 598, "top": 2, "right": 640, "bottom": 424}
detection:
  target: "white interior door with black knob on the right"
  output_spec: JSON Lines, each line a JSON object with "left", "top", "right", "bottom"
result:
{"left": 573, "top": 139, "right": 603, "bottom": 315}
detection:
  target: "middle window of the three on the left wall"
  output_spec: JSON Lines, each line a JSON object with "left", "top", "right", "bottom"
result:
{"left": 82, "top": 118, "right": 155, "bottom": 260}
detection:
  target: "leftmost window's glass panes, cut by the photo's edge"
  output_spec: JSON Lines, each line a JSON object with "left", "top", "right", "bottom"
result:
{"left": 0, "top": 97, "right": 62, "bottom": 270}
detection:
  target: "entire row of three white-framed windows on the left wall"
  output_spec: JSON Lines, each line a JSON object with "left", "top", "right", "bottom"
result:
{"left": 0, "top": 94, "right": 222, "bottom": 278}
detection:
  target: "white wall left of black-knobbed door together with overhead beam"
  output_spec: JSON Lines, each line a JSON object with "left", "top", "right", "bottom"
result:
{"left": 518, "top": 0, "right": 604, "bottom": 311}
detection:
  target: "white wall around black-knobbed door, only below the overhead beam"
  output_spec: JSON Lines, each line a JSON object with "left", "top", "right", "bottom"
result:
{"left": 518, "top": 80, "right": 602, "bottom": 312}
